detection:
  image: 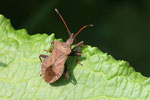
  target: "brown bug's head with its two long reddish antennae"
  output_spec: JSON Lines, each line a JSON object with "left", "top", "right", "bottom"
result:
{"left": 55, "top": 8, "right": 93, "bottom": 45}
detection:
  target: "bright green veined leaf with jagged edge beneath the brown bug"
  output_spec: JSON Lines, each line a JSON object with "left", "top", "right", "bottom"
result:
{"left": 0, "top": 15, "right": 150, "bottom": 100}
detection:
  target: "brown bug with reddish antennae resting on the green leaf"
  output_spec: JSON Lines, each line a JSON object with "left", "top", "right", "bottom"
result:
{"left": 39, "top": 9, "right": 93, "bottom": 83}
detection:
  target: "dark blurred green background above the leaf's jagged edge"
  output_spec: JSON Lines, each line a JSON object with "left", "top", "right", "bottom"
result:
{"left": 0, "top": 0, "right": 150, "bottom": 76}
